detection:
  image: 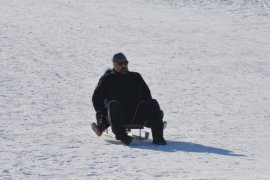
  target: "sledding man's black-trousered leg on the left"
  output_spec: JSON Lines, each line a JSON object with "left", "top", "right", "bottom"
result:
{"left": 108, "top": 100, "right": 132, "bottom": 145}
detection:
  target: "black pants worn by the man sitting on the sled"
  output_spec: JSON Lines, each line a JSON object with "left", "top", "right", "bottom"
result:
{"left": 107, "top": 99, "right": 163, "bottom": 139}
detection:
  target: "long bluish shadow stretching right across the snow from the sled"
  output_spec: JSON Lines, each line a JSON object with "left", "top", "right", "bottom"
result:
{"left": 130, "top": 141, "right": 245, "bottom": 157}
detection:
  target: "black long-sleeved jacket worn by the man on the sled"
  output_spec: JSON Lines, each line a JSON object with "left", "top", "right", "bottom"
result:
{"left": 92, "top": 70, "right": 152, "bottom": 113}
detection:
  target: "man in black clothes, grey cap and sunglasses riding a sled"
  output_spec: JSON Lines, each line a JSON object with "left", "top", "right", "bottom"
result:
{"left": 92, "top": 53, "right": 167, "bottom": 145}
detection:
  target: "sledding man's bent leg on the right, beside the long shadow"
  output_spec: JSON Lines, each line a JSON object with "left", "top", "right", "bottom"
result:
{"left": 135, "top": 99, "right": 166, "bottom": 145}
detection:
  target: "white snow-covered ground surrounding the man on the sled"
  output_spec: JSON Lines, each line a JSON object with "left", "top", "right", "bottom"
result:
{"left": 0, "top": 0, "right": 270, "bottom": 180}
